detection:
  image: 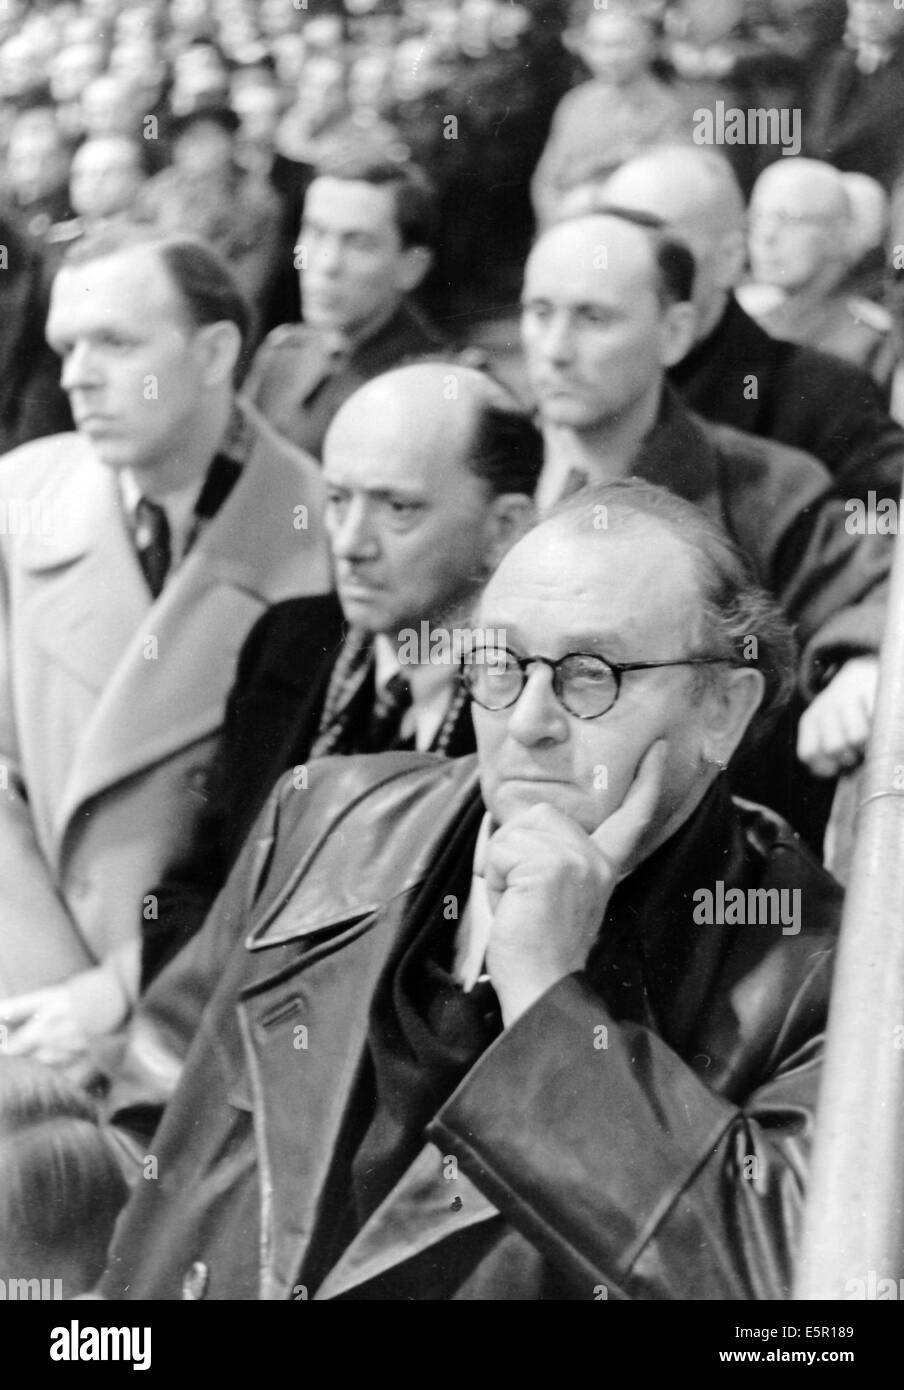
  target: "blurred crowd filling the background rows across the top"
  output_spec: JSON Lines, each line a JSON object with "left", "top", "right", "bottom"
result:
{"left": 0, "top": 0, "right": 904, "bottom": 448}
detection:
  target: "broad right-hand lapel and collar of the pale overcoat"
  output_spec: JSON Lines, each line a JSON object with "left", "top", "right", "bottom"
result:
{"left": 56, "top": 408, "right": 332, "bottom": 842}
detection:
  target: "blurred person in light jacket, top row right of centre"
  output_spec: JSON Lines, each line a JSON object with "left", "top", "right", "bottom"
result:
{"left": 531, "top": 6, "right": 678, "bottom": 225}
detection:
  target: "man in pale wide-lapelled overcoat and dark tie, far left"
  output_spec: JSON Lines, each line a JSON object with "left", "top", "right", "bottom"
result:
{"left": 0, "top": 227, "right": 331, "bottom": 1074}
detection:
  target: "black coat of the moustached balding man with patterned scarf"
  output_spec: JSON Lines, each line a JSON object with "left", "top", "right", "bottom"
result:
{"left": 142, "top": 594, "right": 474, "bottom": 990}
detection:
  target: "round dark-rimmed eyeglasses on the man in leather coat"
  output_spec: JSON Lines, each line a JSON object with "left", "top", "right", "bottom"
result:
{"left": 460, "top": 646, "right": 729, "bottom": 719}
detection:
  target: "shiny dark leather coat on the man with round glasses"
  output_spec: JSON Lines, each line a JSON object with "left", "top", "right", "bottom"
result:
{"left": 103, "top": 753, "right": 841, "bottom": 1301}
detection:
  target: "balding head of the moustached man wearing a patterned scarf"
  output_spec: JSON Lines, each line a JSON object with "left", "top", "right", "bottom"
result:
{"left": 324, "top": 361, "right": 542, "bottom": 635}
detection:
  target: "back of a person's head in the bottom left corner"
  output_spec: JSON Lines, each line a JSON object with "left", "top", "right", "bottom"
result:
{"left": 0, "top": 1054, "right": 128, "bottom": 1298}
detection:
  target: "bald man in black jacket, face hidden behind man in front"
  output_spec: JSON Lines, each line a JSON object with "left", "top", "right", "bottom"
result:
{"left": 595, "top": 145, "right": 904, "bottom": 502}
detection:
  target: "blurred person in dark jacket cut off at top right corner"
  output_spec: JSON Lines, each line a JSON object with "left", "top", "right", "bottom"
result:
{"left": 804, "top": 0, "right": 904, "bottom": 190}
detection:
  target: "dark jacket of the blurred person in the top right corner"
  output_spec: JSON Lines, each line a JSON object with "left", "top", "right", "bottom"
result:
{"left": 804, "top": 43, "right": 904, "bottom": 192}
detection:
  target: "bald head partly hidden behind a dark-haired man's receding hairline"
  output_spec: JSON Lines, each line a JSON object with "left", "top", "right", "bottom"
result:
{"left": 598, "top": 145, "right": 744, "bottom": 338}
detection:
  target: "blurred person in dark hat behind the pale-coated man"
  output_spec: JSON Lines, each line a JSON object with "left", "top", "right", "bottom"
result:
{"left": 138, "top": 106, "right": 281, "bottom": 344}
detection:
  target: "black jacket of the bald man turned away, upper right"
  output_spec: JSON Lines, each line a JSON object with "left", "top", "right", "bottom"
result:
{"left": 669, "top": 299, "right": 904, "bottom": 500}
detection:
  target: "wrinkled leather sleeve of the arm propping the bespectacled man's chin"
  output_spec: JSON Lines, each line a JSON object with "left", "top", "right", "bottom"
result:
{"left": 430, "top": 958, "right": 829, "bottom": 1300}
